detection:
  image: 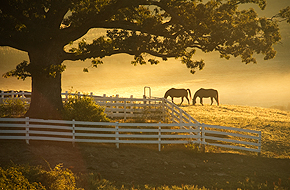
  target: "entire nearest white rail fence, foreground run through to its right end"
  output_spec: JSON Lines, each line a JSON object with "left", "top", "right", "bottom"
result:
{"left": 0, "top": 118, "right": 261, "bottom": 153}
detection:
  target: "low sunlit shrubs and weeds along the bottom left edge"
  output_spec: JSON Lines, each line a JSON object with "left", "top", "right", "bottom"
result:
{"left": 0, "top": 164, "right": 207, "bottom": 190}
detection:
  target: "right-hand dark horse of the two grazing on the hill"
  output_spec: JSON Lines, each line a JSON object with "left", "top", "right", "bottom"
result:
{"left": 192, "top": 88, "right": 220, "bottom": 105}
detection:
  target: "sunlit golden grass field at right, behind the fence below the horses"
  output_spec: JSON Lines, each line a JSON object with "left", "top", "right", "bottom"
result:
{"left": 181, "top": 105, "right": 290, "bottom": 159}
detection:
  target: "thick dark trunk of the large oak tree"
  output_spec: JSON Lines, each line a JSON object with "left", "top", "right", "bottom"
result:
{"left": 25, "top": 48, "right": 63, "bottom": 119}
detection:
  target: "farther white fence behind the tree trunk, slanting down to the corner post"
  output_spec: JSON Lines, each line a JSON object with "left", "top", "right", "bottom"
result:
{"left": 0, "top": 91, "right": 199, "bottom": 123}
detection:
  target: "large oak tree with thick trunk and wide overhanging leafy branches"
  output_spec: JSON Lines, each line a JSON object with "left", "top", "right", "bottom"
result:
{"left": 0, "top": 0, "right": 289, "bottom": 119}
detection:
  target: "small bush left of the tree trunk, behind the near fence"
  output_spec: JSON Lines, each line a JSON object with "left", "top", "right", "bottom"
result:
{"left": 0, "top": 98, "right": 28, "bottom": 117}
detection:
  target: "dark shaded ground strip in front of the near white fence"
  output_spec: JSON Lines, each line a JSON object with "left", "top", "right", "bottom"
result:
{"left": 0, "top": 140, "right": 290, "bottom": 189}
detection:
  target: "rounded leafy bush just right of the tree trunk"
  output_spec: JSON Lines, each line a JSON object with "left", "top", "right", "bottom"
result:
{"left": 63, "top": 93, "right": 109, "bottom": 122}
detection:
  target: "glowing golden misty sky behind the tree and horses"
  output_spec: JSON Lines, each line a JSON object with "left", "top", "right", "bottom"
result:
{"left": 0, "top": 0, "right": 290, "bottom": 107}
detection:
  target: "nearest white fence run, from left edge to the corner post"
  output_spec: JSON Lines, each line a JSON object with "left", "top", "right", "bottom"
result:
{"left": 0, "top": 118, "right": 201, "bottom": 151}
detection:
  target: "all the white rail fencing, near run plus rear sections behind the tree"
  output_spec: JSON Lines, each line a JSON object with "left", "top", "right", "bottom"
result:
{"left": 0, "top": 92, "right": 261, "bottom": 153}
